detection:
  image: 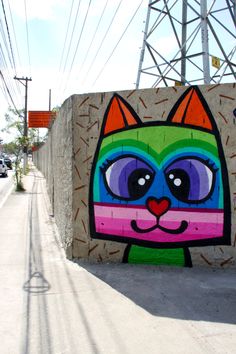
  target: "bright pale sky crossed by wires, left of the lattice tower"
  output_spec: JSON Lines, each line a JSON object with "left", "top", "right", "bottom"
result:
{"left": 0, "top": 0, "right": 148, "bottom": 110}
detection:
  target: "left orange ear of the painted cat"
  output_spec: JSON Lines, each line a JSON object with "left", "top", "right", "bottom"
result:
{"left": 103, "top": 94, "right": 141, "bottom": 135}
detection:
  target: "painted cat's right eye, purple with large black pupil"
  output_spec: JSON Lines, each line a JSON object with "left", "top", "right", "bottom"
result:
{"left": 165, "top": 157, "right": 215, "bottom": 203}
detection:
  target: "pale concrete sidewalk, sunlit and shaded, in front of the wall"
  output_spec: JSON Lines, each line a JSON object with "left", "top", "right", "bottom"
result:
{"left": 0, "top": 169, "right": 236, "bottom": 354}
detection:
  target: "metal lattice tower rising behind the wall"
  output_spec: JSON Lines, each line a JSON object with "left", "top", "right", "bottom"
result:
{"left": 136, "top": 0, "right": 236, "bottom": 88}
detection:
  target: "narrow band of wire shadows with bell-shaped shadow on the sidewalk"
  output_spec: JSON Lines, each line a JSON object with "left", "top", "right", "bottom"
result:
{"left": 21, "top": 169, "right": 52, "bottom": 354}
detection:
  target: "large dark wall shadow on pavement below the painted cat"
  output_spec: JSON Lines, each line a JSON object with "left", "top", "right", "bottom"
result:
{"left": 80, "top": 263, "right": 236, "bottom": 324}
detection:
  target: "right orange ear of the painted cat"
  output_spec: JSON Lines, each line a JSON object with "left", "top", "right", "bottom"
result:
{"left": 167, "top": 86, "right": 214, "bottom": 130}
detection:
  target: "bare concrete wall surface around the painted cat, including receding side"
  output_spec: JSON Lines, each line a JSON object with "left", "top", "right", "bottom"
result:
{"left": 33, "top": 84, "right": 236, "bottom": 267}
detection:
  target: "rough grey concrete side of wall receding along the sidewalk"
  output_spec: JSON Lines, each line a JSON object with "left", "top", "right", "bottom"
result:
{"left": 34, "top": 98, "right": 73, "bottom": 257}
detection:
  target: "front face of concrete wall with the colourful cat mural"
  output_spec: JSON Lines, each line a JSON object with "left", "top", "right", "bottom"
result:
{"left": 33, "top": 84, "right": 236, "bottom": 267}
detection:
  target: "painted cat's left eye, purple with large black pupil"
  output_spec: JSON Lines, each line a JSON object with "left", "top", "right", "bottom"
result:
{"left": 103, "top": 156, "right": 154, "bottom": 200}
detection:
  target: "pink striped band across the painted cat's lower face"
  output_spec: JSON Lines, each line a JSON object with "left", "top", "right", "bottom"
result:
{"left": 95, "top": 206, "right": 224, "bottom": 242}
